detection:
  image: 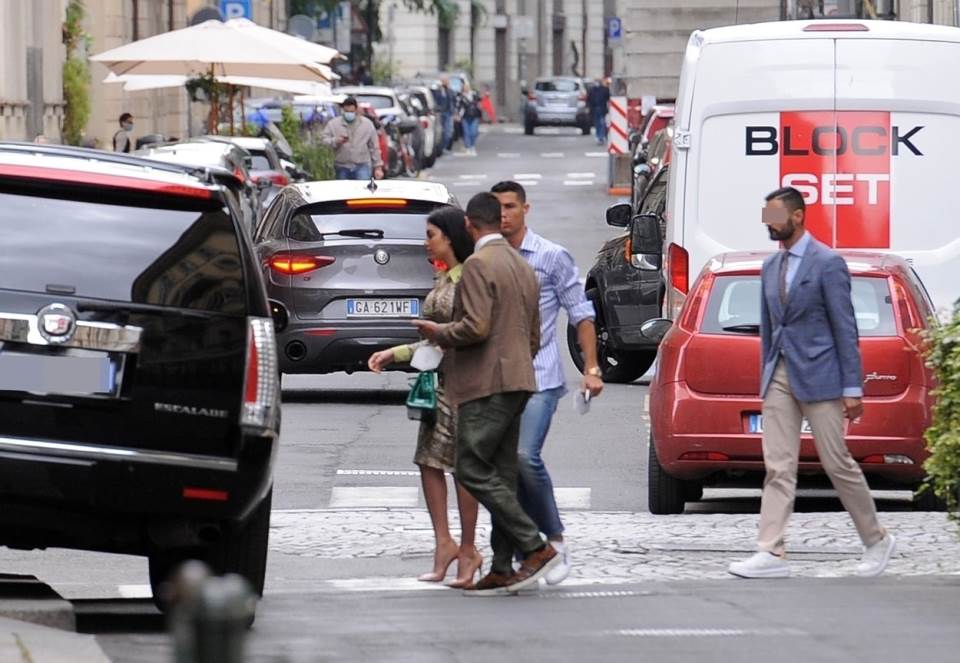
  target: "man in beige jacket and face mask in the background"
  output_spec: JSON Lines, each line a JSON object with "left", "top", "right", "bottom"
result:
{"left": 321, "top": 97, "right": 383, "bottom": 180}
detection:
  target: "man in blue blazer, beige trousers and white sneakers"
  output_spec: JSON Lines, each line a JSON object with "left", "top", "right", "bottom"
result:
{"left": 729, "top": 187, "right": 896, "bottom": 578}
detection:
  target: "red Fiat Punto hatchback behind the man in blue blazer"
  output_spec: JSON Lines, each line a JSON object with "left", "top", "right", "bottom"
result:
{"left": 647, "top": 252, "right": 937, "bottom": 514}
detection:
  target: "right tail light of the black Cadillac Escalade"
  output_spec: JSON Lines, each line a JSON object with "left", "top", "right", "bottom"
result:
{"left": 240, "top": 318, "right": 280, "bottom": 430}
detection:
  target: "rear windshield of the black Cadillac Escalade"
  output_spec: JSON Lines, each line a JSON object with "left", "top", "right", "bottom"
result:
{"left": 0, "top": 190, "right": 246, "bottom": 315}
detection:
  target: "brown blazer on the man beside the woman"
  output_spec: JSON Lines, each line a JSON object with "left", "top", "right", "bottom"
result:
{"left": 437, "top": 239, "right": 540, "bottom": 405}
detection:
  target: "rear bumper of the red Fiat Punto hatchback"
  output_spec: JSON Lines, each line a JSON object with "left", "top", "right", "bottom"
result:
{"left": 650, "top": 382, "right": 928, "bottom": 486}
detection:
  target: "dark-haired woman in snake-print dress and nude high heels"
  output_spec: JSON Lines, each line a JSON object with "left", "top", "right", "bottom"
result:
{"left": 368, "top": 207, "right": 483, "bottom": 587}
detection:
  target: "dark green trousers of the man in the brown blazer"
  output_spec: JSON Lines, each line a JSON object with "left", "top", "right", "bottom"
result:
{"left": 456, "top": 391, "right": 543, "bottom": 574}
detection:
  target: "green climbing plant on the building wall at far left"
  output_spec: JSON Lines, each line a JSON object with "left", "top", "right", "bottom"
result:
{"left": 63, "top": 0, "right": 91, "bottom": 145}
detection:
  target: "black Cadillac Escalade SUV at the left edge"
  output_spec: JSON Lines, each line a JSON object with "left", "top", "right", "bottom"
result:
{"left": 0, "top": 143, "right": 280, "bottom": 616}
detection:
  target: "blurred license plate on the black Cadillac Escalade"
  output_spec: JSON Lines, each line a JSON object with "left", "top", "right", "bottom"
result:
{"left": 0, "top": 350, "right": 118, "bottom": 396}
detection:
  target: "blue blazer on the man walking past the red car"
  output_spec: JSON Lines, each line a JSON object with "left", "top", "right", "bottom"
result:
{"left": 760, "top": 238, "right": 863, "bottom": 402}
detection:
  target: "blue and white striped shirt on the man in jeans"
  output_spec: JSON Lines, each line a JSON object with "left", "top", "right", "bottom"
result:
{"left": 520, "top": 228, "right": 596, "bottom": 391}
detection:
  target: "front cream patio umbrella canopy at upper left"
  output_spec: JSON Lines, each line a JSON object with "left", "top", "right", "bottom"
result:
{"left": 91, "top": 19, "right": 340, "bottom": 82}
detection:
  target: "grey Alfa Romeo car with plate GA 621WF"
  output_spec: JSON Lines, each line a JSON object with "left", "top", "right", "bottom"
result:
{"left": 254, "top": 180, "right": 456, "bottom": 373}
